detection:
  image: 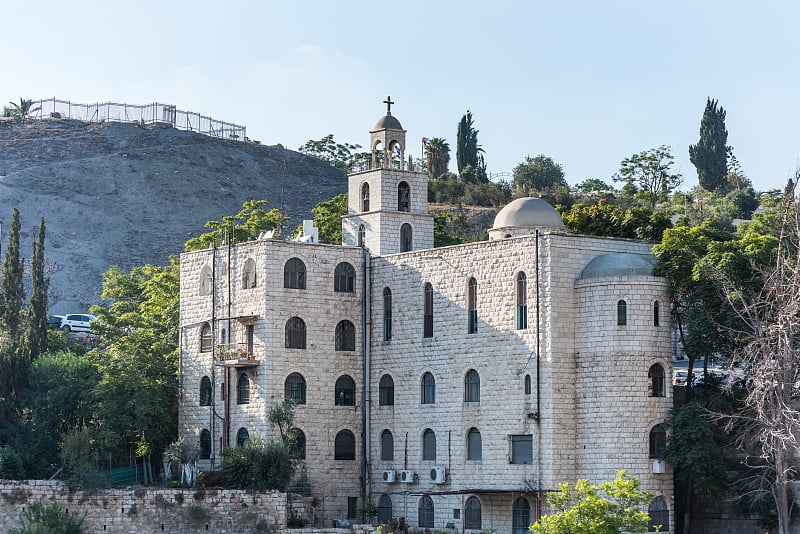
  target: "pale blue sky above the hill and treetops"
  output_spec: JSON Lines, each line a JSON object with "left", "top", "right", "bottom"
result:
{"left": 0, "top": 0, "right": 800, "bottom": 195}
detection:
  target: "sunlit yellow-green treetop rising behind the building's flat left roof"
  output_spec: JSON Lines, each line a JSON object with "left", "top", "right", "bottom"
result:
{"left": 184, "top": 200, "right": 284, "bottom": 252}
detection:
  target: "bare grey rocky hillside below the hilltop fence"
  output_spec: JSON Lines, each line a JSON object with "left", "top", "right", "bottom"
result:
{"left": 0, "top": 119, "right": 347, "bottom": 314}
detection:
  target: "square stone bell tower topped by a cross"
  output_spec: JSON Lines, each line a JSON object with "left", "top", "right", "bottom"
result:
{"left": 342, "top": 97, "right": 433, "bottom": 256}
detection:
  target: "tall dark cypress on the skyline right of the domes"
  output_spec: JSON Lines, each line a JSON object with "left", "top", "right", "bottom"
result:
{"left": 689, "top": 98, "right": 728, "bottom": 192}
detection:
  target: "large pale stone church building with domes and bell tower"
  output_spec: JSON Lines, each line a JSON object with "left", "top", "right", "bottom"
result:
{"left": 180, "top": 102, "right": 674, "bottom": 533}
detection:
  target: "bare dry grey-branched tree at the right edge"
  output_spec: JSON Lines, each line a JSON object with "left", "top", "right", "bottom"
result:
{"left": 715, "top": 177, "right": 800, "bottom": 534}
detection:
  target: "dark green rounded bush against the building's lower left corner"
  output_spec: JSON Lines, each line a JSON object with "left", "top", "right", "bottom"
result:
{"left": 220, "top": 434, "right": 294, "bottom": 491}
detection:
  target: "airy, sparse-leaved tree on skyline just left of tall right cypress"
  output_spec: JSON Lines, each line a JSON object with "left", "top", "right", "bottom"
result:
{"left": 614, "top": 145, "right": 683, "bottom": 208}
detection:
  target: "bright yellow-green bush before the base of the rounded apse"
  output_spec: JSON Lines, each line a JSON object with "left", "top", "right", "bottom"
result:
{"left": 530, "top": 471, "right": 653, "bottom": 534}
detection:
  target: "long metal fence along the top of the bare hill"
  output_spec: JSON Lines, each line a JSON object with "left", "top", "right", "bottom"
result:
{"left": 31, "top": 98, "right": 247, "bottom": 141}
